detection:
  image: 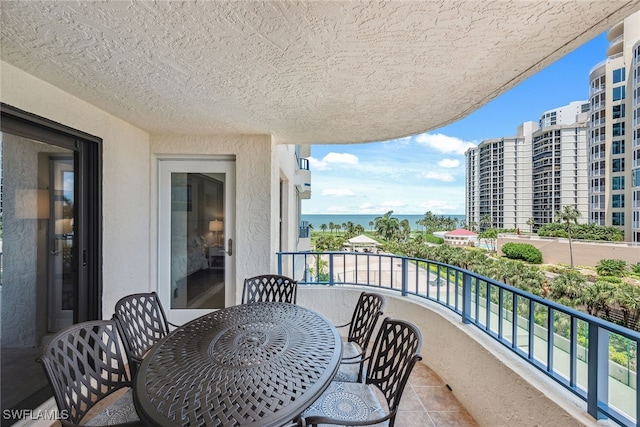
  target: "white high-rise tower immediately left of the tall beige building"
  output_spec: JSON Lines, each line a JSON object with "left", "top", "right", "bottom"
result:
{"left": 530, "top": 101, "right": 589, "bottom": 230}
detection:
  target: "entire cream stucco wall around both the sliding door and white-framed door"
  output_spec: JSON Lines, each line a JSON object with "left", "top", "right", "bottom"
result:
{"left": 0, "top": 62, "right": 298, "bottom": 318}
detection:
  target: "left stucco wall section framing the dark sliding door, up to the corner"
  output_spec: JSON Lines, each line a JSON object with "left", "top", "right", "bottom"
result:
{"left": 0, "top": 62, "right": 150, "bottom": 318}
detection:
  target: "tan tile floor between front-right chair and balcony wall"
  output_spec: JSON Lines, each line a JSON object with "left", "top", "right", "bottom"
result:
{"left": 395, "top": 362, "right": 478, "bottom": 427}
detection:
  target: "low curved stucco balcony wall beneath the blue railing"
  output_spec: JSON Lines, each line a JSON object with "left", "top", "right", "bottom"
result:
{"left": 298, "top": 286, "right": 604, "bottom": 427}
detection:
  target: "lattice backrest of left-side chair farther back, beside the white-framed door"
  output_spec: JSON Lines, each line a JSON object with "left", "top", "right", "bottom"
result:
{"left": 113, "top": 292, "right": 169, "bottom": 375}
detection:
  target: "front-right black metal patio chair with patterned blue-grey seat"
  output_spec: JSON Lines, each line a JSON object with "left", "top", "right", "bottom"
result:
{"left": 299, "top": 318, "right": 422, "bottom": 427}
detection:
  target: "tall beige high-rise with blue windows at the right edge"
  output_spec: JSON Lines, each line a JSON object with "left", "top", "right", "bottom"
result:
{"left": 589, "top": 13, "right": 640, "bottom": 242}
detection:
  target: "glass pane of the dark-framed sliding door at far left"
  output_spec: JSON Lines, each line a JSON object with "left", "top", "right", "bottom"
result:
{"left": 0, "top": 133, "right": 77, "bottom": 425}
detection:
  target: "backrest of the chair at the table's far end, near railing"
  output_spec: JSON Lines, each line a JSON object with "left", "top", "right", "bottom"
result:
{"left": 242, "top": 274, "right": 298, "bottom": 304}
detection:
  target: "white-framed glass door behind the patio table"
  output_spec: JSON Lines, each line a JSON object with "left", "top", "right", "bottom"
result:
{"left": 158, "top": 161, "right": 234, "bottom": 322}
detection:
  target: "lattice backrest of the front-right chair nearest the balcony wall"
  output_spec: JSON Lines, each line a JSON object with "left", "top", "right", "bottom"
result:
{"left": 365, "top": 317, "right": 422, "bottom": 425}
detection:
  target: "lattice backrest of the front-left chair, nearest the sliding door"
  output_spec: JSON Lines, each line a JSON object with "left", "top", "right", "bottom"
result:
{"left": 37, "top": 320, "right": 131, "bottom": 424}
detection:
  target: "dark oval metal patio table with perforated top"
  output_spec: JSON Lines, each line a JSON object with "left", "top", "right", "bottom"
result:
{"left": 134, "top": 302, "right": 342, "bottom": 427}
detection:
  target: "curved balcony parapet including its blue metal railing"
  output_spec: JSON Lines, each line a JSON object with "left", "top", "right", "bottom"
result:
{"left": 278, "top": 252, "right": 640, "bottom": 426}
